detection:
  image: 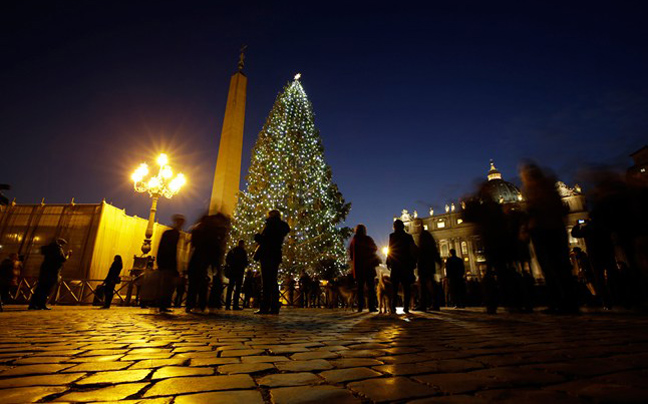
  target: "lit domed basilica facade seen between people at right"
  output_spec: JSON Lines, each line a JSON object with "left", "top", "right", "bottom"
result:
{"left": 394, "top": 161, "right": 588, "bottom": 279}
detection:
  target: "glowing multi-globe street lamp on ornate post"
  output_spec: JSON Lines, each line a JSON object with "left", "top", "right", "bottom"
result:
{"left": 131, "top": 153, "right": 187, "bottom": 255}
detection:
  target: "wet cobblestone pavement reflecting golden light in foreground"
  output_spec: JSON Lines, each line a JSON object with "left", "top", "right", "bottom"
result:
{"left": 0, "top": 306, "right": 648, "bottom": 404}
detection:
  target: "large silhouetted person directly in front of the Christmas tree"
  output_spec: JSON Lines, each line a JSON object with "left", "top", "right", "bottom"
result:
{"left": 254, "top": 210, "right": 290, "bottom": 314}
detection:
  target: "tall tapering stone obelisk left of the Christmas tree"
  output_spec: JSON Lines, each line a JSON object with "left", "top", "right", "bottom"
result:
{"left": 209, "top": 46, "right": 247, "bottom": 217}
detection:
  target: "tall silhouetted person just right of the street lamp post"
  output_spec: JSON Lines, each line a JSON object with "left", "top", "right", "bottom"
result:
{"left": 157, "top": 215, "right": 185, "bottom": 313}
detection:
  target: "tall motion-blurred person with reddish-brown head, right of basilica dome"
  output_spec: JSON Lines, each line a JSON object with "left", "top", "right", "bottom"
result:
{"left": 520, "top": 164, "right": 578, "bottom": 313}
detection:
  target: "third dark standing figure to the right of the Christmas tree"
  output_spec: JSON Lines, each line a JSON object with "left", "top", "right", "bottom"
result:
{"left": 416, "top": 230, "right": 442, "bottom": 311}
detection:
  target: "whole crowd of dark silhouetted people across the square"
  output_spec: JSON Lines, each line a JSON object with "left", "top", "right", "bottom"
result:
{"left": 0, "top": 164, "right": 648, "bottom": 314}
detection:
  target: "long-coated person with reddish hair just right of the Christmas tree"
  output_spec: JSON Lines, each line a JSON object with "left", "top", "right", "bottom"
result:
{"left": 349, "top": 224, "right": 380, "bottom": 313}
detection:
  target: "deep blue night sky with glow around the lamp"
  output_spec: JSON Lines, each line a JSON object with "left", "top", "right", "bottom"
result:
{"left": 0, "top": 1, "right": 648, "bottom": 244}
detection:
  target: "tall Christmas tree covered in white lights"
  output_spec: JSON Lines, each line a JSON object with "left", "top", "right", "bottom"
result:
{"left": 230, "top": 75, "right": 351, "bottom": 276}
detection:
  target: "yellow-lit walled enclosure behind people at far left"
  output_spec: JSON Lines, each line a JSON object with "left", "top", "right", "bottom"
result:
{"left": 0, "top": 202, "right": 186, "bottom": 279}
